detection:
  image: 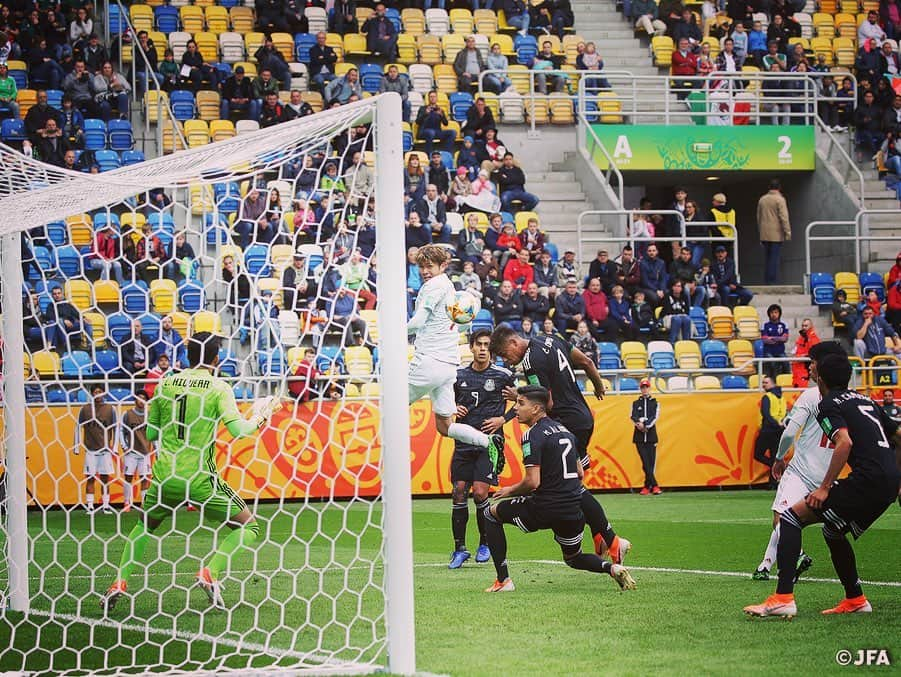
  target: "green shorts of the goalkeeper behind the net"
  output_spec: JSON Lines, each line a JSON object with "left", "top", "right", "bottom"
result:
{"left": 144, "top": 475, "right": 247, "bottom": 522}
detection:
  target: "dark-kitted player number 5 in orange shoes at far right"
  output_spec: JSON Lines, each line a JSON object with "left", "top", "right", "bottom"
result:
{"left": 745, "top": 355, "right": 901, "bottom": 617}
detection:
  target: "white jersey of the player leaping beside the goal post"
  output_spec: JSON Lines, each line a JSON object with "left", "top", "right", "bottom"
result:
{"left": 409, "top": 273, "right": 460, "bottom": 365}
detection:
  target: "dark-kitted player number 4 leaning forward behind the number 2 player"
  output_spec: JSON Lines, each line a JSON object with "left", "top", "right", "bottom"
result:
{"left": 491, "top": 326, "right": 632, "bottom": 564}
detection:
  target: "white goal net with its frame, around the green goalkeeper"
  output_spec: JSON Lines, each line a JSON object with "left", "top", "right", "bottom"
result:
{"left": 0, "top": 95, "right": 413, "bottom": 674}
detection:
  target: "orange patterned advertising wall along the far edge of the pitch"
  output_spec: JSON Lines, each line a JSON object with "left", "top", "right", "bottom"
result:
{"left": 8, "top": 393, "right": 780, "bottom": 506}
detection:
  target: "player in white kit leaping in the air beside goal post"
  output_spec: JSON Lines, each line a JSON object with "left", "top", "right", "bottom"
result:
{"left": 407, "top": 244, "right": 504, "bottom": 473}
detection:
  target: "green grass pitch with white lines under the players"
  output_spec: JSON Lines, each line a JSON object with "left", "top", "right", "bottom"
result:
{"left": 0, "top": 491, "right": 901, "bottom": 675}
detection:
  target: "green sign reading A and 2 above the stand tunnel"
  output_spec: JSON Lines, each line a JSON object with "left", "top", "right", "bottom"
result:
{"left": 587, "top": 124, "right": 816, "bottom": 172}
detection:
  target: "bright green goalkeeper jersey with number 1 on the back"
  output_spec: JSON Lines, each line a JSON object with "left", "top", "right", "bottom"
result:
{"left": 147, "top": 369, "right": 241, "bottom": 482}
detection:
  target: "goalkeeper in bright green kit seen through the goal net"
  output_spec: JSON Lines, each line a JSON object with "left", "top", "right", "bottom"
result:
{"left": 100, "top": 332, "right": 279, "bottom": 611}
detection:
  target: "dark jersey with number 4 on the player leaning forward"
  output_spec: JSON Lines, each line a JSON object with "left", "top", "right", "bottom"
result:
{"left": 522, "top": 336, "right": 594, "bottom": 430}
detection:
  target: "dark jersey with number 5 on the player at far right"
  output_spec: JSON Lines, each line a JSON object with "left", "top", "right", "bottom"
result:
{"left": 817, "top": 390, "right": 899, "bottom": 489}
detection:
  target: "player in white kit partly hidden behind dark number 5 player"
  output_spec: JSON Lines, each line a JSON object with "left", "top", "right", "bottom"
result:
{"left": 752, "top": 341, "right": 845, "bottom": 583}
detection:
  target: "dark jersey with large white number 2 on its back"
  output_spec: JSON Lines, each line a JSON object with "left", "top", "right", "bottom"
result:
{"left": 522, "top": 416, "right": 582, "bottom": 512}
